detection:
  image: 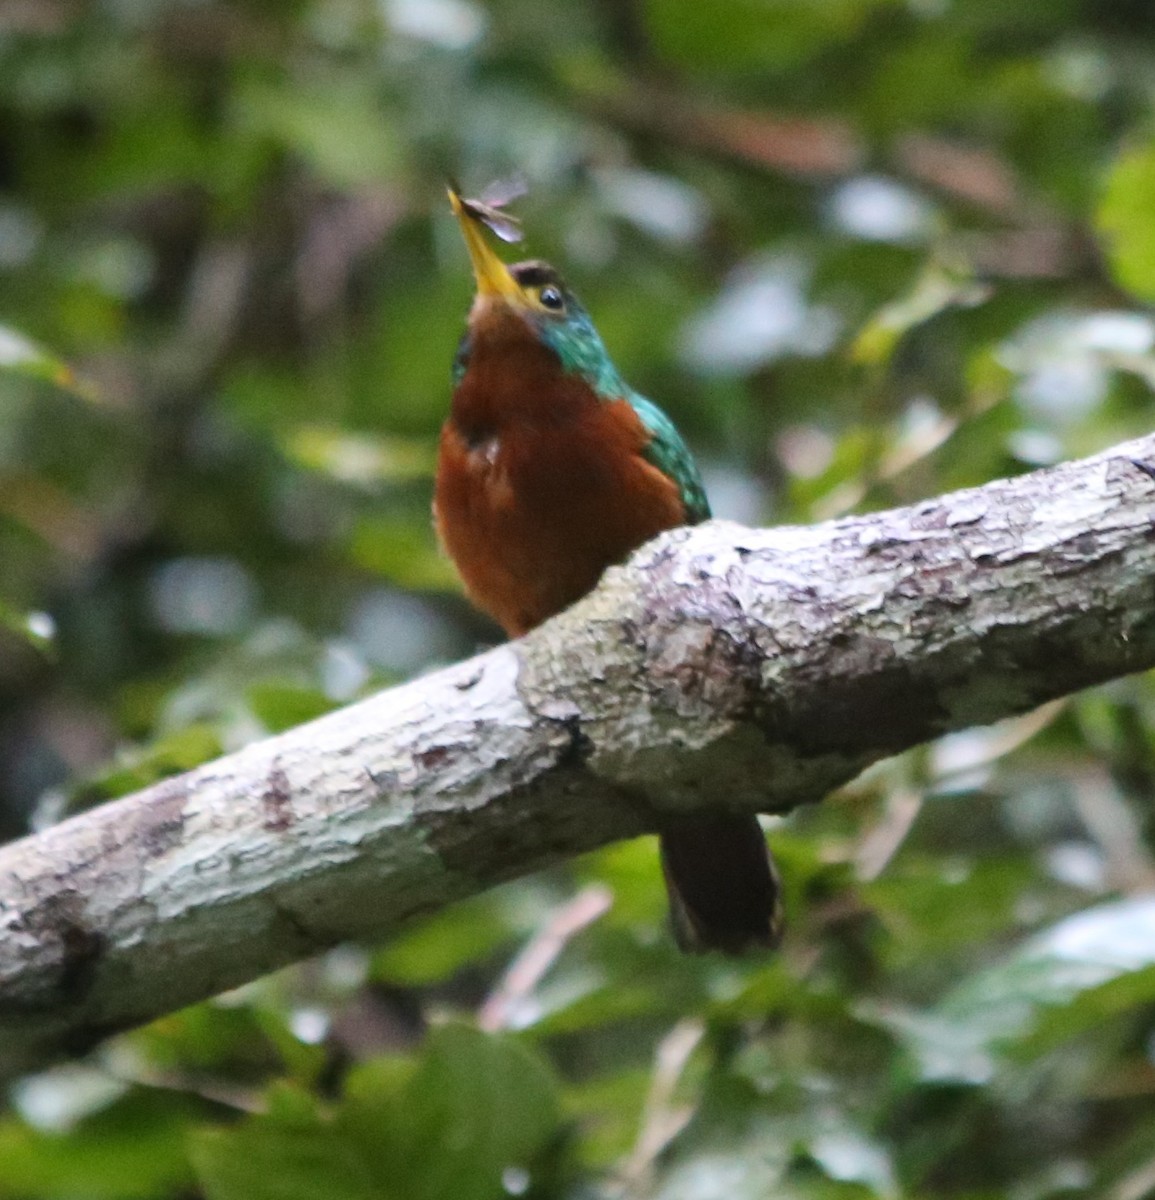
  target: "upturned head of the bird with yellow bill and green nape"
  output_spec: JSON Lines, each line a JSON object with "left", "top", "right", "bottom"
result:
{"left": 449, "top": 187, "right": 626, "bottom": 397}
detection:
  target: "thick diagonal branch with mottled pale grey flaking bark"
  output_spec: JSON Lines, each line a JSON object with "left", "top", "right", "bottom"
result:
{"left": 0, "top": 438, "right": 1155, "bottom": 1073}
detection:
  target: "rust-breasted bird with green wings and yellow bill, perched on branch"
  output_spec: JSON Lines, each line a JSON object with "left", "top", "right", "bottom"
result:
{"left": 433, "top": 185, "right": 782, "bottom": 955}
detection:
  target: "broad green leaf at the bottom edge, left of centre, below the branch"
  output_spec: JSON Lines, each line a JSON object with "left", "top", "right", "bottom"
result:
{"left": 192, "top": 1026, "right": 558, "bottom": 1200}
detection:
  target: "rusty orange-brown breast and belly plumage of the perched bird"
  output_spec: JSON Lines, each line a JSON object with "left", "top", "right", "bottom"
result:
{"left": 435, "top": 306, "right": 686, "bottom": 637}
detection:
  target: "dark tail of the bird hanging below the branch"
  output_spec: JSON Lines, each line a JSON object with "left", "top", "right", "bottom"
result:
{"left": 659, "top": 814, "right": 783, "bottom": 954}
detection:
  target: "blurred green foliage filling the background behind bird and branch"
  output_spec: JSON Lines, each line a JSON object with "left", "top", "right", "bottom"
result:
{"left": 0, "top": 0, "right": 1155, "bottom": 1200}
